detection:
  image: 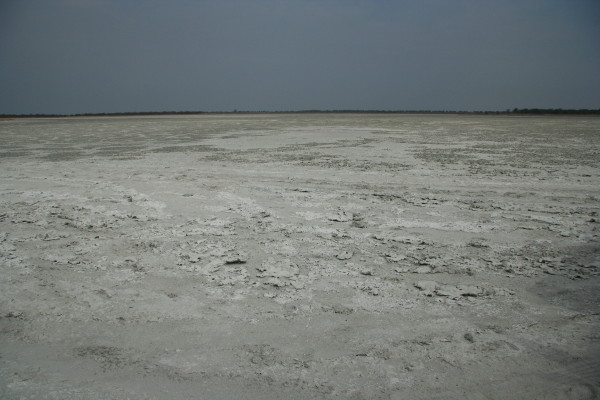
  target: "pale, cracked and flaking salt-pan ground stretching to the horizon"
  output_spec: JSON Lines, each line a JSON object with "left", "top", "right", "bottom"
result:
{"left": 0, "top": 115, "right": 600, "bottom": 399}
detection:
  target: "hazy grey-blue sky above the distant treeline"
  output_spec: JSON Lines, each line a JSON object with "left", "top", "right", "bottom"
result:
{"left": 0, "top": 0, "right": 600, "bottom": 114}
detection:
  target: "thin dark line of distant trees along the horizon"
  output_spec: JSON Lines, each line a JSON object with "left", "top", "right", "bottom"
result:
{"left": 0, "top": 108, "right": 600, "bottom": 118}
